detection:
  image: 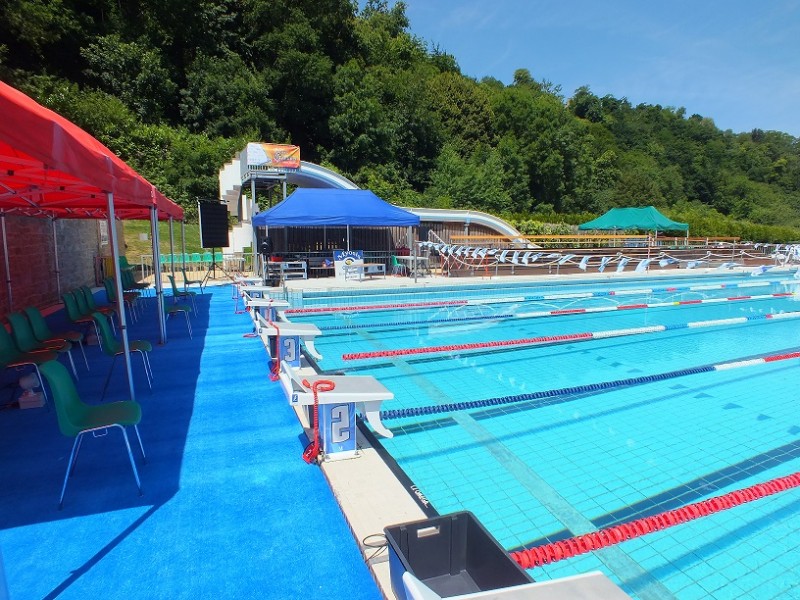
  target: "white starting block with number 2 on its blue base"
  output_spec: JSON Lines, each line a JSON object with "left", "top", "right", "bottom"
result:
{"left": 279, "top": 361, "right": 394, "bottom": 460}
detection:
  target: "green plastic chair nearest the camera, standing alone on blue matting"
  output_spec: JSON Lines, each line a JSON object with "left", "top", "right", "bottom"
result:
{"left": 42, "top": 358, "right": 147, "bottom": 509}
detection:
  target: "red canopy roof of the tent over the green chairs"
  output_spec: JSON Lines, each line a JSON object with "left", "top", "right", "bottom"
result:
{"left": 0, "top": 82, "right": 183, "bottom": 219}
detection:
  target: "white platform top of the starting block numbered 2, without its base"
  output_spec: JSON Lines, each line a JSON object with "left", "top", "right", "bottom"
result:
{"left": 279, "top": 361, "right": 394, "bottom": 438}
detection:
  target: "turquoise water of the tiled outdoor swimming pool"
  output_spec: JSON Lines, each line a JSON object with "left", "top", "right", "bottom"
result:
{"left": 289, "top": 274, "right": 800, "bottom": 599}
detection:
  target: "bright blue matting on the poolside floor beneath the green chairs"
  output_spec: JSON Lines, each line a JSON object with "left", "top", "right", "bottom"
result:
{"left": 0, "top": 286, "right": 381, "bottom": 600}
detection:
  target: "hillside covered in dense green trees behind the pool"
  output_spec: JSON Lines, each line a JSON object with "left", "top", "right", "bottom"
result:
{"left": 0, "top": 0, "right": 800, "bottom": 241}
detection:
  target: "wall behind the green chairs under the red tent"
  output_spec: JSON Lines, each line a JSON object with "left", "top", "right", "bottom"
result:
{"left": 0, "top": 215, "right": 110, "bottom": 319}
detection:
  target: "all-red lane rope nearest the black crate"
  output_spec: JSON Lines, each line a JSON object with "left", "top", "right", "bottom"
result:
{"left": 511, "top": 472, "right": 800, "bottom": 569}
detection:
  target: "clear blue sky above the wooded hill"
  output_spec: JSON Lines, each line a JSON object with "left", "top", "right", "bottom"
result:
{"left": 390, "top": 0, "right": 800, "bottom": 137}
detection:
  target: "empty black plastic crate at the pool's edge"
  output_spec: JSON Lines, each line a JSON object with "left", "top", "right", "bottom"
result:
{"left": 384, "top": 511, "right": 533, "bottom": 600}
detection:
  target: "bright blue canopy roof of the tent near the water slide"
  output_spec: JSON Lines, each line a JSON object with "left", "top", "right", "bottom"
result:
{"left": 253, "top": 188, "right": 419, "bottom": 227}
